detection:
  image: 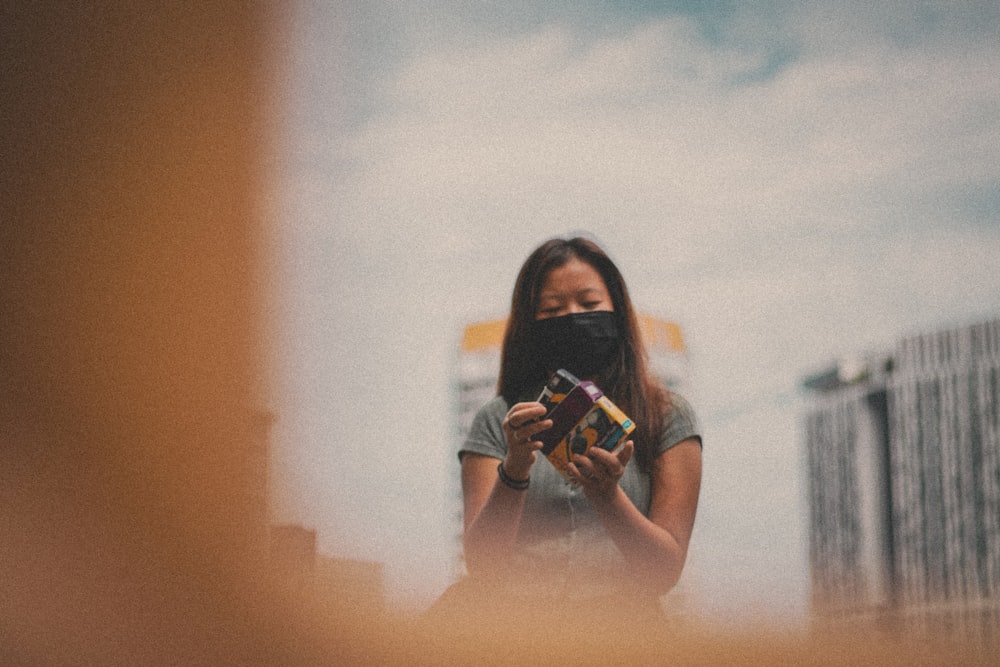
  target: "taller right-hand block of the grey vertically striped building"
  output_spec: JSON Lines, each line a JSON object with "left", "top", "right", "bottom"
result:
{"left": 889, "top": 322, "right": 1000, "bottom": 604}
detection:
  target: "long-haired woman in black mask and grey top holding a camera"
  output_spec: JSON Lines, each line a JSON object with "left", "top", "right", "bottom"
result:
{"left": 459, "top": 238, "right": 701, "bottom": 614}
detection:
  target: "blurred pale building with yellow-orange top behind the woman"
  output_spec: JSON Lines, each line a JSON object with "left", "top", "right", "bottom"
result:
{"left": 448, "top": 314, "right": 688, "bottom": 578}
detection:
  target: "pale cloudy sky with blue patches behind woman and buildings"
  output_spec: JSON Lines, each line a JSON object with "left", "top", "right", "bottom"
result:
{"left": 272, "top": 0, "right": 1000, "bottom": 622}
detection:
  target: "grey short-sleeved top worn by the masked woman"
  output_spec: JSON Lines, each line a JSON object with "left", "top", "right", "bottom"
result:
{"left": 459, "top": 393, "right": 701, "bottom": 599}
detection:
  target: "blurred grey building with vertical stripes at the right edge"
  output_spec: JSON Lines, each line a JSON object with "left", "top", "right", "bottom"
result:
{"left": 804, "top": 320, "right": 1000, "bottom": 638}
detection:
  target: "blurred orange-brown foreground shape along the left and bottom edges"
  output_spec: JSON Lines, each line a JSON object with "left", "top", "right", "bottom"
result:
{"left": 0, "top": 2, "right": 992, "bottom": 665}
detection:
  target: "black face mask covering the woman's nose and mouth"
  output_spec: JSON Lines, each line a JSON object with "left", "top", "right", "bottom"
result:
{"left": 531, "top": 310, "right": 620, "bottom": 378}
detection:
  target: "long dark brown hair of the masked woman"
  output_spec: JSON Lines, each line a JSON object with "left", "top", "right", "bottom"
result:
{"left": 497, "top": 237, "right": 670, "bottom": 471}
